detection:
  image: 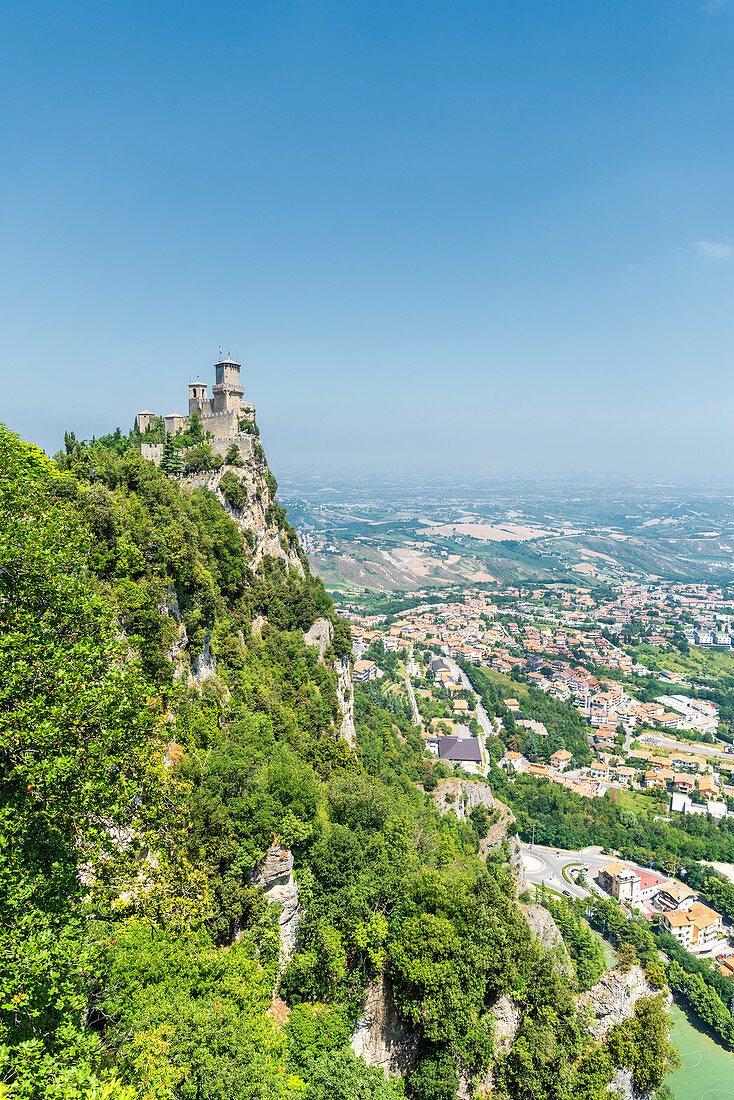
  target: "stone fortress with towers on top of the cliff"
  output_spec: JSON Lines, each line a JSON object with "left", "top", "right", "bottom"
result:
{"left": 138, "top": 358, "right": 255, "bottom": 465}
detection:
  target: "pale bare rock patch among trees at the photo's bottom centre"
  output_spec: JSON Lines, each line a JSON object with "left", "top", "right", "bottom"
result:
{"left": 350, "top": 975, "right": 419, "bottom": 1077}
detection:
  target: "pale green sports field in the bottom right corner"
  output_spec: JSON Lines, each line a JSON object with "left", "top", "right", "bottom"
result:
{"left": 666, "top": 1004, "right": 734, "bottom": 1100}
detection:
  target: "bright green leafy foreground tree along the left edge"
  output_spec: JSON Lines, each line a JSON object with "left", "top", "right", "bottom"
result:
{"left": 0, "top": 427, "right": 166, "bottom": 1097}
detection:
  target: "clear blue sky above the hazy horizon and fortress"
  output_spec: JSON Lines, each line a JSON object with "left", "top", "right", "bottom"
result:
{"left": 0, "top": 0, "right": 734, "bottom": 475}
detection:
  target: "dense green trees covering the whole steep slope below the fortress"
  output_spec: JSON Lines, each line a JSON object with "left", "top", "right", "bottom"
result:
{"left": 0, "top": 430, "right": 682, "bottom": 1100}
